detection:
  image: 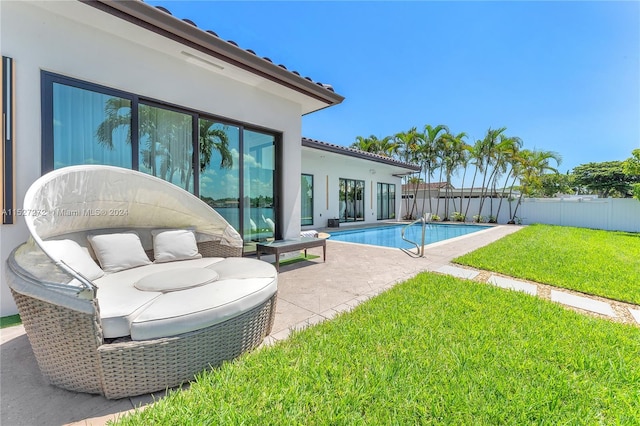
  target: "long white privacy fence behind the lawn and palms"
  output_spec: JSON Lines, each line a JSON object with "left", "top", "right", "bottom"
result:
{"left": 402, "top": 197, "right": 640, "bottom": 232}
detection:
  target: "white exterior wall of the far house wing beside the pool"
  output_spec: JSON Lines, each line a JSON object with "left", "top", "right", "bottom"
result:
{"left": 297, "top": 147, "right": 402, "bottom": 230}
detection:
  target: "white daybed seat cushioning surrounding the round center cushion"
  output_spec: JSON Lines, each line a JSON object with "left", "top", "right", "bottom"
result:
{"left": 96, "top": 257, "right": 278, "bottom": 340}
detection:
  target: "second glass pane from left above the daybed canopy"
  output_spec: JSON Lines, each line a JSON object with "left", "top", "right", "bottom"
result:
{"left": 138, "top": 103, "right": 194, "bottom": 192}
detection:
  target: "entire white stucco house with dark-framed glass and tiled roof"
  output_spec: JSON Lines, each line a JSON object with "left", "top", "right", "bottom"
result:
{"left": 0, "top": 0, "right": 418, "bottom": 316}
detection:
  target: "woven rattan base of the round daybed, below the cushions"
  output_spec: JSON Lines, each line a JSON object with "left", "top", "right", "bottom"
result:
{"left": 13, "top": 291, "right": 276, "bottom": 399}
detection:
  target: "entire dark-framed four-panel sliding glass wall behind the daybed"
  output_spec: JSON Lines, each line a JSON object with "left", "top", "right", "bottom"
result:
{"left": 41, "top": 71, "right": 280, "bottom": 246}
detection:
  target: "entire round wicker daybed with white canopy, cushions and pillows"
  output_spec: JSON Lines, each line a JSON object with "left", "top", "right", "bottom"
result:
{"left": 6, "top": 166, "right": 277, "bottom": 399}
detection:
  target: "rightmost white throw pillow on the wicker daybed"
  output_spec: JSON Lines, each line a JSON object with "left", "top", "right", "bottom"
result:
{"left": 151, "top": 229, "right": 202, "bottom": 263}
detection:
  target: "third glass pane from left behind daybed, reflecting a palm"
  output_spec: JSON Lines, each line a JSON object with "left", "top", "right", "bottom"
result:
{"left": 198, "top": 118, "right": 240, "bottom": 230}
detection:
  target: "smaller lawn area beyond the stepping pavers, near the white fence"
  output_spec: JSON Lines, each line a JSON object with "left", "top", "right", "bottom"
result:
{"left": 454, "top": 225, "right": 640, "bottom": 304}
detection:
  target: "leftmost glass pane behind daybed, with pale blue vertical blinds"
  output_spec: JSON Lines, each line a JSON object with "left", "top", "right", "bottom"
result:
{"left": 52, "top": 83, "right": 132, "bottom": 169}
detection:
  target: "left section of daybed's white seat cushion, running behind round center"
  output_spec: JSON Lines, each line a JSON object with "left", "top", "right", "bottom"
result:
{"left": 95, "top": 257, "right": 223, "bottom": 339}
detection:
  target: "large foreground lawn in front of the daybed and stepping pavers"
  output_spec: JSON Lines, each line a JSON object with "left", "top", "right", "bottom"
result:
{"left": 114, "top": 273, "right": 640, "bottom": 425}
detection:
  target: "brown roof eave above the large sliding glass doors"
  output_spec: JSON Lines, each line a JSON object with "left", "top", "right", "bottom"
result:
{"left": 79, "top": 0, "right": 344, "bottom": 106}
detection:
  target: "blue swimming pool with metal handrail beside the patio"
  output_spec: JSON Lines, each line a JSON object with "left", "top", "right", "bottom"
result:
{"left": 330, "top": 223, "right": 490, "bottom": 249}
